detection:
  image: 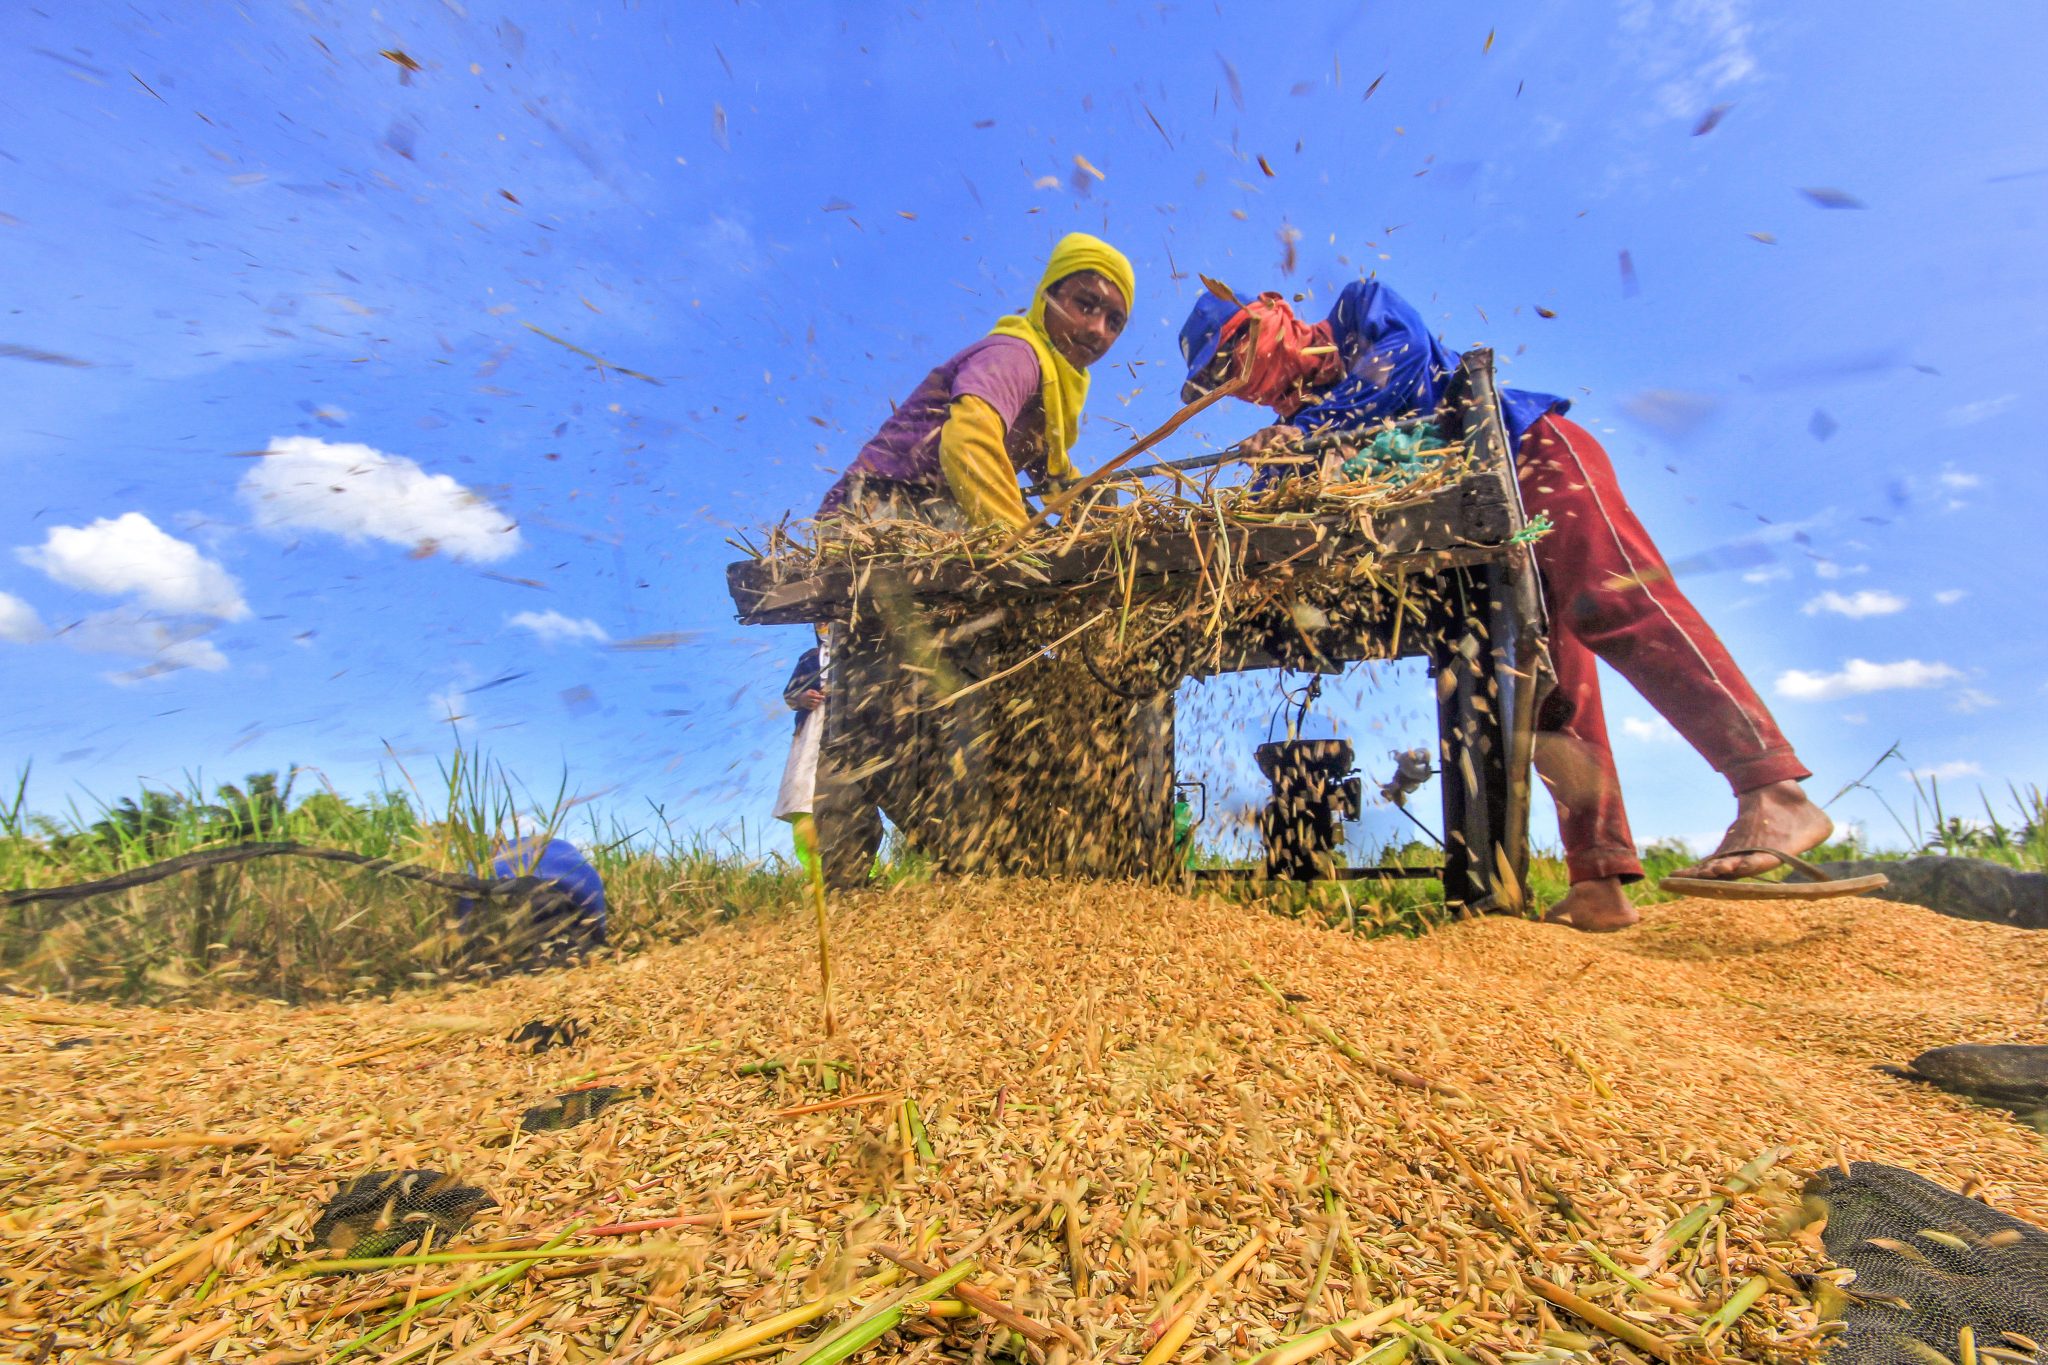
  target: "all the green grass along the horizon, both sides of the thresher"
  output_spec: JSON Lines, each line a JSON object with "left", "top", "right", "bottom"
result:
{"left": 0, "top": 745, "right": 2048, "bottom": 1003}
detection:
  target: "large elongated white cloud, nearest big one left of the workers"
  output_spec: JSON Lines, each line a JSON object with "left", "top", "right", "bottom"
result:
{"left": 242, "top": 436, "right": 520, "bottom": 561}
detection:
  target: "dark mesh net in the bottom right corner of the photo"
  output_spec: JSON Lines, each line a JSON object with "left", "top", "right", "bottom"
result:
{"left": 1806, "top": 1160, "right": 2048, "bottom": 1365}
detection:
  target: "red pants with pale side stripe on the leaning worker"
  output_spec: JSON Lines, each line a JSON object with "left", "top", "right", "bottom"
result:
{"left": 1516, "top": 413, "right": 1810, "bottom": 882}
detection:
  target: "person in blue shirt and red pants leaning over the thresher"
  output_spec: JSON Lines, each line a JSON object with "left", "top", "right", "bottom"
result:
{"left": 1180, "top": 280, "right": 1833, "bottom": 931}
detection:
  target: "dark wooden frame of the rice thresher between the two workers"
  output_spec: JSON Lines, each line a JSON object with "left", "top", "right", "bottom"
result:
{"left": 727, "top": 350, "right": 1546, "bottom": 913}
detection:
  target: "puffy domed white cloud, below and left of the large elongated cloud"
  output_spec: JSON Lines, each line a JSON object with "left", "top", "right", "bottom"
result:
{"left": 14, "top": 512, "right": 250, "bottom": 620}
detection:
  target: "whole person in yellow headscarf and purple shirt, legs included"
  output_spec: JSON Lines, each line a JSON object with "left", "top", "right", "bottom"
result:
{"left": 813, "top": 233, "right": 1137, "bottom": 886}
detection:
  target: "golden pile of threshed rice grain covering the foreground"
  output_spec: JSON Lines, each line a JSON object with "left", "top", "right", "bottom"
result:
{"left": 0, "top": 882, "right": 2048, "bottom": 1365}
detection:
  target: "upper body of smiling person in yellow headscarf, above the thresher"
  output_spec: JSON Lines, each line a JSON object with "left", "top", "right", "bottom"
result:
{"left": 817, "top": 233, "right": 1137, "bottom": 526}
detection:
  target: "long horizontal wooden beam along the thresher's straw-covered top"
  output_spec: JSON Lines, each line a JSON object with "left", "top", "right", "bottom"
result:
{"left": 725, "top": 475, "right": 1513, "bottom": 626}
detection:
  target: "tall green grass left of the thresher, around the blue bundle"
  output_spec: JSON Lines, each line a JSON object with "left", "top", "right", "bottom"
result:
{"left": 0, "top": 747, "right": 801, "bottom": 1003}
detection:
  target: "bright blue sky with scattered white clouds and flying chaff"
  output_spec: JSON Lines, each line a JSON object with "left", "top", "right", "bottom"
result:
{"left": 0, "top": 0, "right": 2048, "bottom": 855}
